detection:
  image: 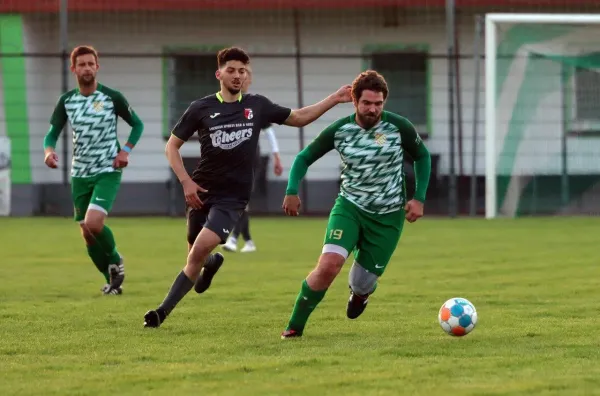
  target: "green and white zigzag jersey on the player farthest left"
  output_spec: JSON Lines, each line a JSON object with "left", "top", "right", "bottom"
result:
{"left": 50, "top": 84, "right": 137, "bottom": 177}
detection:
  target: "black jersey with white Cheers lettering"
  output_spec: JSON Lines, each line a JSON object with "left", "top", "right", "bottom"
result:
{"left": 172, "top": 93, "right": 291, "bottom": 200}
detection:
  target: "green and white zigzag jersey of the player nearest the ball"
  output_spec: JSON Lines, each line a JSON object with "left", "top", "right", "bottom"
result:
{"left": 290, "top": 111, "right": 428, "bottom": 214}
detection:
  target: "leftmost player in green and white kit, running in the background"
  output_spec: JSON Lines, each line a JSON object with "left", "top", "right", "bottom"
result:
{"left": 44, "top": 46, "right": 144, "bottom": 295}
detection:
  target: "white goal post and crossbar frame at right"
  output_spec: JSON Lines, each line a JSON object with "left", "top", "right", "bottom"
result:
{"left": 484, "top": 13, "right": 600, "bottom": 219}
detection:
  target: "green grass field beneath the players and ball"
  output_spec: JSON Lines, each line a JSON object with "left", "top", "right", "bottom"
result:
{"left": 0, "top": 218, "right": 600, "bottom": 396}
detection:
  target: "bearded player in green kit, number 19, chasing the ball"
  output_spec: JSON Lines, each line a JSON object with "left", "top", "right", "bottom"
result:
{"left": 281, "top": 70, "right": 431, "bottom": 339}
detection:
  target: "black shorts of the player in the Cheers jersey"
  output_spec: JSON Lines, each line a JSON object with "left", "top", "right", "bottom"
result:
{"left": 186, "top": 197, "right": 248, "bottom": 245}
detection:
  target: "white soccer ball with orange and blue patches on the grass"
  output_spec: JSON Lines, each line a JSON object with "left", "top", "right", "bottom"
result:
{"left": 438, "top": 297, "right": 477, "bottom": 337}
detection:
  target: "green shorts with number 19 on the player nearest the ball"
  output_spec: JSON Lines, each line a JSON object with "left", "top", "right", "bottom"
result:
{"left": 323, "top": 196, "right": 405, "bottom": 276}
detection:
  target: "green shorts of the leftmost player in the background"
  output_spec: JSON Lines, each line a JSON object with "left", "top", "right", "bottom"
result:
{"left": 71, "top": 171, "right": 122, "bottom": 221}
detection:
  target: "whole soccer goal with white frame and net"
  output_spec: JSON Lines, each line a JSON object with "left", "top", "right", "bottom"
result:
{"left": 486, "top": 14, "right": 600, "bottom": 218}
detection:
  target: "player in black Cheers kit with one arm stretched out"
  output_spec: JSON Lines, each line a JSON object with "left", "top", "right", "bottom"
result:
{"left": 144, "top": 47, "right": 352, "bottom": 327}
